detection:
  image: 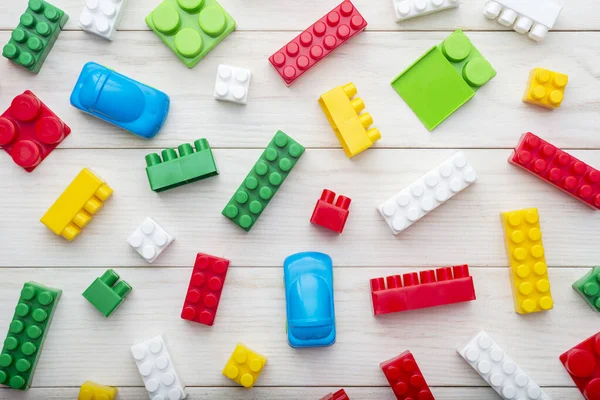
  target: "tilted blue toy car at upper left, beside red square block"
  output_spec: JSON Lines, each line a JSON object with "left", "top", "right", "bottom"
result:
{"left": 71, "top": 62, "right": 170, "bottom": 139}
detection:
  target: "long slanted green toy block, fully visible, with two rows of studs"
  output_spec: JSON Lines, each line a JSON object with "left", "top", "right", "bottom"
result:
{"left": 223, "top": 131, "right": 304, "bottom": 232}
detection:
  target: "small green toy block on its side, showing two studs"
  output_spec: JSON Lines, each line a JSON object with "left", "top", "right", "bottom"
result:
{"left": 83, "top": 269, "right": 131, "bottom": 318}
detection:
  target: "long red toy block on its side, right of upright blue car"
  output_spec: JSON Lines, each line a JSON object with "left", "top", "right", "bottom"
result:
{"left": 371, "top": 265, "right": 476, "bottom": 315}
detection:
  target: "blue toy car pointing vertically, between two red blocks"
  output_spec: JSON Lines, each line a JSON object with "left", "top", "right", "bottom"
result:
{"left": 283, "top": 252, "right": 335, "bottom": 347}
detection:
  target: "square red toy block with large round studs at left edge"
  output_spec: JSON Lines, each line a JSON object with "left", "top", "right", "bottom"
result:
{"left": 0, "top": 90, "right": 71, "bottom": 172}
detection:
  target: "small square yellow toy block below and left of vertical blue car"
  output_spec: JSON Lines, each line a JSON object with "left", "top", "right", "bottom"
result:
{"left": 223, "top": 343, "right": 267, "bottom": 388}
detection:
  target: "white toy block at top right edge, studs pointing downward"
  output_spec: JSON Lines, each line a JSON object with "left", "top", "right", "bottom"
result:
{"left": 483, "top": 0, "right": 562, "bottom": 42}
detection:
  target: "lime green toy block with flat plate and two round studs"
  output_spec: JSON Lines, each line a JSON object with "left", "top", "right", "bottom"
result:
{"left": 392, "top": 30, "right": 496, "bottom": 131}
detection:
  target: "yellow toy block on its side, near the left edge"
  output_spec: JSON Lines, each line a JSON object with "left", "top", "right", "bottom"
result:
{"left": 40, "top": 168, "right": 113, "bottom": 240}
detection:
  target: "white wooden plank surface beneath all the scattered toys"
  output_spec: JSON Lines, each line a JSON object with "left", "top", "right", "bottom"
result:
{"left": 0, "top": 0, "right": 600, "bottom": 400}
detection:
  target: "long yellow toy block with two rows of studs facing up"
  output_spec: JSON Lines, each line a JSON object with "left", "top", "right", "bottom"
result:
{"left": 500, "top": 208, "right": 554, "bottom": 314}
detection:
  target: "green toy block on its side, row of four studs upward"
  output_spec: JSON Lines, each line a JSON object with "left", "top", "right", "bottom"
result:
{"left": 146, "top": 139, "right": 219, "bottom": 192}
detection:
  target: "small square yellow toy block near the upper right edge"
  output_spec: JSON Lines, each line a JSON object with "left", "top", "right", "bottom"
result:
{"left": 523, "top": 68, "right": 569, "bottom": 110}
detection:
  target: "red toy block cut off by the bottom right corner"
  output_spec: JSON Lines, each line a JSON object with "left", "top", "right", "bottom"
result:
{"left": 559, "top": 333, "right": 600, "bottom": 400}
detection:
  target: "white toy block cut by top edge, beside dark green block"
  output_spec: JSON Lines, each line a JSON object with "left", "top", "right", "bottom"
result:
{"left": 79, "top": 0, "right": 126, "bottom": 40}
